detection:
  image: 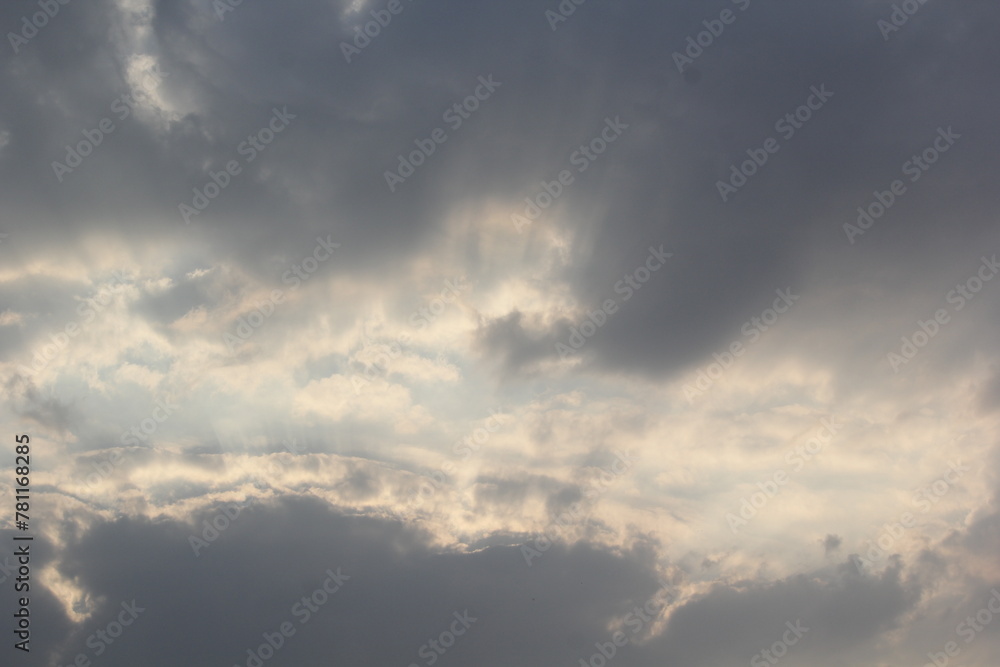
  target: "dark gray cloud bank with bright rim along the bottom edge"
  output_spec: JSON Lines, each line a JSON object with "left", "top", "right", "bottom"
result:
{"left": 1, "top": 498, "right": 917, "bottom": 665}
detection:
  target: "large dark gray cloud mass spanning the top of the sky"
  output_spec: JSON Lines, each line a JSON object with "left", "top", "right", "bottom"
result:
{"left": 3, "top": 2, "right": 996, "bottom": 386}
